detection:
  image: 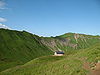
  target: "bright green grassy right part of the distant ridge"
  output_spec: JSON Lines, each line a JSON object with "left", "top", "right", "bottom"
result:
{"left": 60, "top": 33, "right": 100, "bottom": 49}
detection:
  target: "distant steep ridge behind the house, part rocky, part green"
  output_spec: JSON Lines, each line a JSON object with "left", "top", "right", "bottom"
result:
{"left": 41, "top": 33, "right": 100, "bottom": 51}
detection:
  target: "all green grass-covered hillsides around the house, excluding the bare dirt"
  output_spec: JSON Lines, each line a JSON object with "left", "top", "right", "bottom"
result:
{"left": 0, "top": 29, "right": 100, "bottom": 75}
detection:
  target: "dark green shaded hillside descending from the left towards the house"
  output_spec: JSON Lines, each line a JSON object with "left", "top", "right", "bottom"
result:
{"left": 0, "top": 29, "right": 52, "bottom": 71}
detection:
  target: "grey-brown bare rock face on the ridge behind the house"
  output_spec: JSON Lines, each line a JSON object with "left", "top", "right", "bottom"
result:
{"left": 41, "top": 38, "right": 78, "bottom": 50}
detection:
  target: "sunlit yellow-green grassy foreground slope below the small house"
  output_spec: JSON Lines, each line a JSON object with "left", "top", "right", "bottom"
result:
{"left": 1, "top": 44, "right": 100, "bottom": 75}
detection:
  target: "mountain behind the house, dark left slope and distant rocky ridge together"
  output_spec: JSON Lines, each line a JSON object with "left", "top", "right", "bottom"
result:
{"left": 0, "top": 28, "right": 100, "bottom": 75}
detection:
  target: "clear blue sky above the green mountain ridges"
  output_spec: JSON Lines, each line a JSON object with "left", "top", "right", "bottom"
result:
{"left": 0, "top": 0, "right": 100, "bottom": 36}
